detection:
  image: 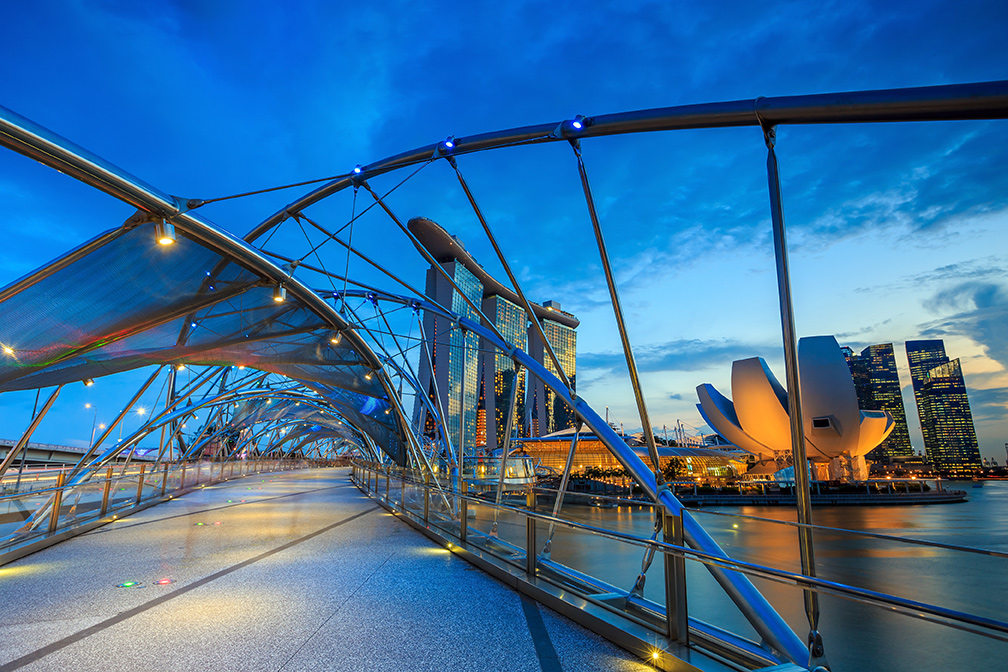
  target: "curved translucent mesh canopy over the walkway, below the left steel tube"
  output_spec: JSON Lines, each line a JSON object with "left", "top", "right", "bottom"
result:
{"left": 0, "top": 224, "right": 404, "bottom": 461}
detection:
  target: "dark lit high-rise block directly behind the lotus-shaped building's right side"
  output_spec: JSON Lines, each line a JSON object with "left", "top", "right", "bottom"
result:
{"left": 841, "top": 343, "right": 913, "bottom": 462}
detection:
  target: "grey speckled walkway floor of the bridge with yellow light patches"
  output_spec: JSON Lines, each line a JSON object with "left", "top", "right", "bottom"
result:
{"left": 0, "top": 468, "right": 651, "bottom": 672}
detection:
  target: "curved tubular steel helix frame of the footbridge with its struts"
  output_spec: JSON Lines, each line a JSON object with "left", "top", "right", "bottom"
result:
{"left": 0, "top": 82, "right": 1008, "bottom": 668}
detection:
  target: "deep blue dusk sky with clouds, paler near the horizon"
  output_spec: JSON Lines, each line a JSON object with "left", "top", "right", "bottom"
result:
{"left": 0, "top": 1, "right": 1008, "bottom": 461}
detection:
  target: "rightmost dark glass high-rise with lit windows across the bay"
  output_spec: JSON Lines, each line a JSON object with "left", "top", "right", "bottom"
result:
{"left": 906, "top": 341, "right": 981, "bottom": 477}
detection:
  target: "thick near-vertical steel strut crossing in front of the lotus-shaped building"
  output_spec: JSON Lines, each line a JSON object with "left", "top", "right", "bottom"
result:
{"left": 763, "top": 126, "right": 830, "bottom": 670}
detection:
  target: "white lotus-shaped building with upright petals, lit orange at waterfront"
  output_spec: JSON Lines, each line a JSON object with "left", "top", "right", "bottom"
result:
{"left": 697, "top": 335, "right": 893, "bottom": 461}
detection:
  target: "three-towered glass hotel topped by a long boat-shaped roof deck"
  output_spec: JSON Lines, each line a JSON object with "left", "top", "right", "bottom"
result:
{"left": 408, "top": 218, "right": 580, "bottom": 455}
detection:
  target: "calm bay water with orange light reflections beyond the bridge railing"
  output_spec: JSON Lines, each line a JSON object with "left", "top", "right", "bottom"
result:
{"left": 524, "top": 482, "right": 1008, "bottom": 672}
